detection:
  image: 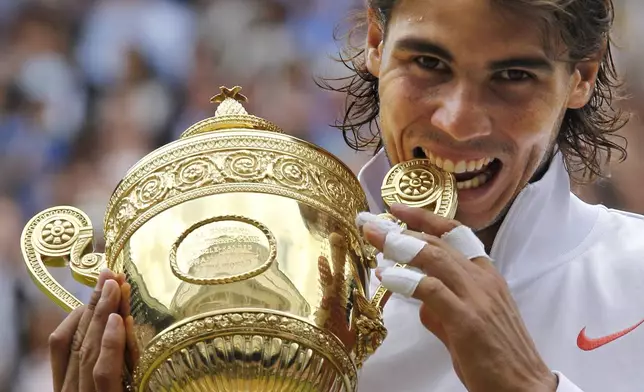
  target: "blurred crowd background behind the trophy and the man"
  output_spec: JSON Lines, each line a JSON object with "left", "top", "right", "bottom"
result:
{"left": 0, "top": 0, "right": 644, "bottom": 392}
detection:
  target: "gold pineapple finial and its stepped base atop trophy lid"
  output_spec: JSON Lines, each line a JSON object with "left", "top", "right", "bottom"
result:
{"left": 181, "top": 86, "right": 284, "bottom": 139}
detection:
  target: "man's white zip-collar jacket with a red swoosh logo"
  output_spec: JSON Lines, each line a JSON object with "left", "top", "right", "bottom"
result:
{"left": 358, "top": 152, "right": 644, "bottom": 392}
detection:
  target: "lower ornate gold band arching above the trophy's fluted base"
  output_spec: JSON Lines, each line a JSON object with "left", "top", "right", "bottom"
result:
{"left": 134, "top": 309, "right": 357, "bottom": 392}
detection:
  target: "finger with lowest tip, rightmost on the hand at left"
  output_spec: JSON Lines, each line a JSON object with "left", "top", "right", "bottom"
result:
{"left": 92, "top": 313, "right": 125, "bottom": 392}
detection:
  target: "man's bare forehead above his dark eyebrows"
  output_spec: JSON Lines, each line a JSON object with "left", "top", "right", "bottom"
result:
{"left": 387, "top": 0, "right": 546, "bottom": 61}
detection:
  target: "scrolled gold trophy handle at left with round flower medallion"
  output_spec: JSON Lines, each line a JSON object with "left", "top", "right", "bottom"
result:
{"left": 20, "top": 206, "right": 106, "bottom": 312}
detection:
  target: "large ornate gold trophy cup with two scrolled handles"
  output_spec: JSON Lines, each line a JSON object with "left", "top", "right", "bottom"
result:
{"left": 21, "top": 87, "right": 456, "bottom": 392}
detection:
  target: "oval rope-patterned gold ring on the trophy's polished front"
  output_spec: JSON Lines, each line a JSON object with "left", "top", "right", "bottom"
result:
{"left": 170, "top": 215, "right": 277, "bottom": 285}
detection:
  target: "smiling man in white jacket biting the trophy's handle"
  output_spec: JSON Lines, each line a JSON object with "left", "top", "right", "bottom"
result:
{"left": 46, "top": 0, "right": 644, "bottom": 392}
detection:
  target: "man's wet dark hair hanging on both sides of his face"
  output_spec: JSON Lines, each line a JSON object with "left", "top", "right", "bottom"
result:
{"left": 319, "top": 0, "right": 628, "bottom": 179}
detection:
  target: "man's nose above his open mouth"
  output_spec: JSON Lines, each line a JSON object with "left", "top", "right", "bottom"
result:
{"left": 432, "top": 84, "right": 492, "bottom": 141}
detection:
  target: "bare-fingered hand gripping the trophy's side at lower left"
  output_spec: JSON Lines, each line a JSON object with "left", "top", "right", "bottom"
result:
{"left": 49, "top": 271, "right": 134, "bottom": 392}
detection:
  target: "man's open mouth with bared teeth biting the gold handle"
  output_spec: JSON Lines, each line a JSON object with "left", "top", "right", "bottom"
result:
{"left": 413, "top": 147, "right": 503, "bottom": 190}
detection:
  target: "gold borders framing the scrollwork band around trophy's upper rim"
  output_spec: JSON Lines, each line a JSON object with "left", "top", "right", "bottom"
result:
{"left": 104, "top": 130, "right": 368, "bottom": 266}
